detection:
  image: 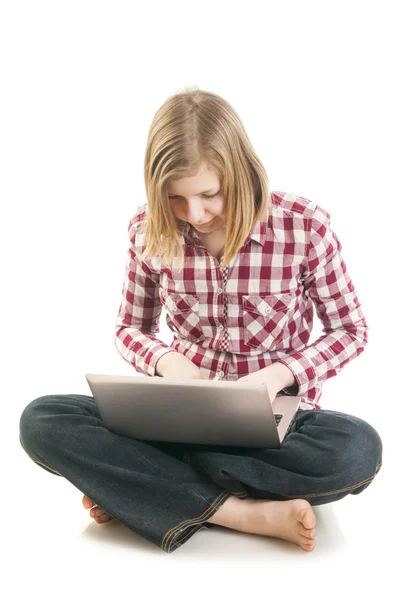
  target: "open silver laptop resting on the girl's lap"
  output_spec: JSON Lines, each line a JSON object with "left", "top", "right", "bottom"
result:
{"left": 86, "top": 373, "right": 300, "bottom": 448}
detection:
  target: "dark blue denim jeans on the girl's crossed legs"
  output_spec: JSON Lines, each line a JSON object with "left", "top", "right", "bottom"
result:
{"left": 19, "top": 394, "right": 383, "bottom": 553}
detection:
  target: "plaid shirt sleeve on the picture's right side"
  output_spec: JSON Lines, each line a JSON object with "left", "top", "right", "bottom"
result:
{"left": 279, "top": 206, "right": 368, "bottom": 396}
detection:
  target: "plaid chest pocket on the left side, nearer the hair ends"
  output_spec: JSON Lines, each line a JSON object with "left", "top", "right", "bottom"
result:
{"left": 160, "top": 290, "right": 205, "bottom": 342}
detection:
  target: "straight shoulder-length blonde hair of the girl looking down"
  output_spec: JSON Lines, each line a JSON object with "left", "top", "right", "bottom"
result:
{"left": 143, "top": 86, "right": 270, "bottom": 268}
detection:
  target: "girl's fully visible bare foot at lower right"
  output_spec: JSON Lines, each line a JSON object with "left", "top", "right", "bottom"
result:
{"left": 241, "top": 498, "right": 316, "bottom": 552}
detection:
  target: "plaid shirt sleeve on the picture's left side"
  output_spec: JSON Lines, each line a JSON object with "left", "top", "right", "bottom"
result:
{"left": 115, "top": 219, "right": 175, "bottom": 377}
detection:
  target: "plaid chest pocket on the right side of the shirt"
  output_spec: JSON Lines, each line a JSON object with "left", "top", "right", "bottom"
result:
{"left": 242, "top": 293, "right": 294, "bottom": 351}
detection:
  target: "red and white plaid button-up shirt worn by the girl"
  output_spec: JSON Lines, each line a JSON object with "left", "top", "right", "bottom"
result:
{"left": 115, "top": 192, "right": 368, "bottom": 410}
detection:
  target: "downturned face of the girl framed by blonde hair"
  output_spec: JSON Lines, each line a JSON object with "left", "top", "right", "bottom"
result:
{"left": 167, "top": 164, "right": 225, "bottom": 233}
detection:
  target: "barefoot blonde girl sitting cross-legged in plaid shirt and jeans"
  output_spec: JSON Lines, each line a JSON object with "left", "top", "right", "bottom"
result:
{"left": 20, "top": 88, "right": 382, "bottom": 553}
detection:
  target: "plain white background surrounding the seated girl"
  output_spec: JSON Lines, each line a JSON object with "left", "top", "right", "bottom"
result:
{"left": 0, "top": 0, "right": 398, "bottom": 599}
